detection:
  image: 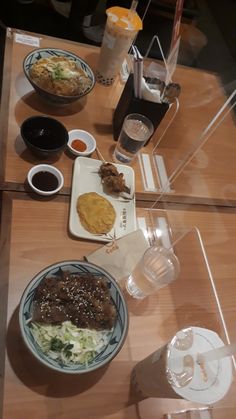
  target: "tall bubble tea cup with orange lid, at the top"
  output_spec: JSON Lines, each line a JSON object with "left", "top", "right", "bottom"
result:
{"left": 96, "top": 6, "right": 142, "bottom": 85}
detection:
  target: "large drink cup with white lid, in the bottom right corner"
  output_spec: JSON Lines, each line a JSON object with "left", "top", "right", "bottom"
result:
{"left": 131, "top": 327, "right": 232, "bottom": 405}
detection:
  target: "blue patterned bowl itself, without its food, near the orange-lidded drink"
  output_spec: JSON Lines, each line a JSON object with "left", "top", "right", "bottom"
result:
{"left": 23, "top": 48, "right": 95, "bottom": 105}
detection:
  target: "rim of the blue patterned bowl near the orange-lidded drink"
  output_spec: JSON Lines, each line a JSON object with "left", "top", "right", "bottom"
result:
{"left": 23, "top": 47, "right": 96, "bottom": 100}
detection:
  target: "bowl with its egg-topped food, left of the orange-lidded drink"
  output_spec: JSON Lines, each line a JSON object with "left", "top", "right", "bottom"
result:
{"left": 23, "top": 48, "right": 95, "bottom": 105}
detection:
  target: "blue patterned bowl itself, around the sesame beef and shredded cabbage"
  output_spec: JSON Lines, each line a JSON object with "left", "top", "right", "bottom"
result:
{"left": 19, "top": 260, "right": 128, "bottom": 374}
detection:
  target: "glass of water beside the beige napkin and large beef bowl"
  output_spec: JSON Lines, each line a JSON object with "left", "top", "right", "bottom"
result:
{"left": 126, "top": 245, "right": 180, "bottom": 299}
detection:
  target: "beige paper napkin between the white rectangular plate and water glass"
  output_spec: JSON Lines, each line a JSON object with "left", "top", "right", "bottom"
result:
{"left": 85, "top": 230, "right": 150, "bottom": 282}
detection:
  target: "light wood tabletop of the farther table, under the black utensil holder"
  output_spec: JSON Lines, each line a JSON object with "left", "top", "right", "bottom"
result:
{"left": 0, "top": 29, "right": 236, "bottom": 205}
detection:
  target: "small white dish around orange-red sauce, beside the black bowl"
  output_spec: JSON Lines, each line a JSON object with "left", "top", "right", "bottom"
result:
{"left": 67, "top": 129, "right": 96, "bottom": 157}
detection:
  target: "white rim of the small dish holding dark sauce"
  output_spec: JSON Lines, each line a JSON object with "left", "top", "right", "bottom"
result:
{"left": 27, "top": 163, "right": 64, "bottom": 196}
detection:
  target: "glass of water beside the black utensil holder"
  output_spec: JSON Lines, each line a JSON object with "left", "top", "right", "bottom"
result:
{"left": 113, "top": 113, "right": 154, "bottom": 164}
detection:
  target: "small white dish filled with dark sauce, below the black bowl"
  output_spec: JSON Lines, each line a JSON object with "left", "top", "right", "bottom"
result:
{"left": 27, "top": 164, "right": 64, "bottom": 196}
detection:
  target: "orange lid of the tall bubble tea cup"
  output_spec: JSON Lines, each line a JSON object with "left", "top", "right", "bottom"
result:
{"left": 106, "top": 6, "right": 143, "bottom": 31}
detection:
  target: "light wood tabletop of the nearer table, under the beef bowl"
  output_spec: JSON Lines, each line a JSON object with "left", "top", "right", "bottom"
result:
{"left": 0, "top": 192, "right": 236, "bottom": 419}
